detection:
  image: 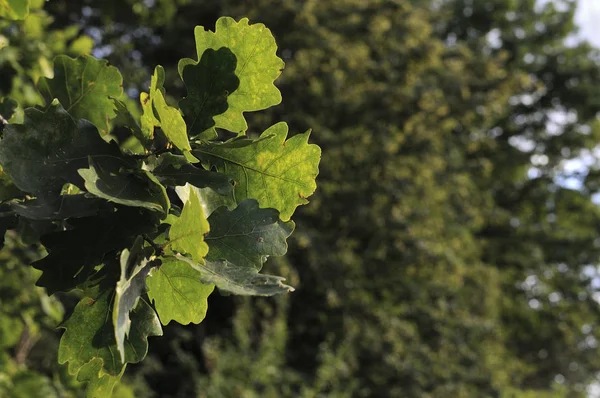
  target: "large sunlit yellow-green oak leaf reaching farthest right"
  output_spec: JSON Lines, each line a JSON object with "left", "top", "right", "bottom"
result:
{"left": 192, "top": 122, "right": 321, "bottom": 221}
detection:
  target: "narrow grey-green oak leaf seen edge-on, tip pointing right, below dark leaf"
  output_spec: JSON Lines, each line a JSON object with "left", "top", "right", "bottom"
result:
{"left": 175, "top": 254, "right": 294, "bottom": 296}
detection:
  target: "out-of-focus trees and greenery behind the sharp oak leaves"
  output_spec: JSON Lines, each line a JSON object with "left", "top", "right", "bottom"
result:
{"left": 0, "top": 0, "right": 600, "bottom": 398}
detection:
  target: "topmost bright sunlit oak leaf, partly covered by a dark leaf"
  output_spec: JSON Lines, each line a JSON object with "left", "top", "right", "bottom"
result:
{"left": 179, "top": 17, "right": 284, "bottom": 134}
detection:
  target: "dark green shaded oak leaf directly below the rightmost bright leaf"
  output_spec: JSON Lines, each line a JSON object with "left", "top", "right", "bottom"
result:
{"left": 204, "top": 199, "right": 294, "bottom": 271}
